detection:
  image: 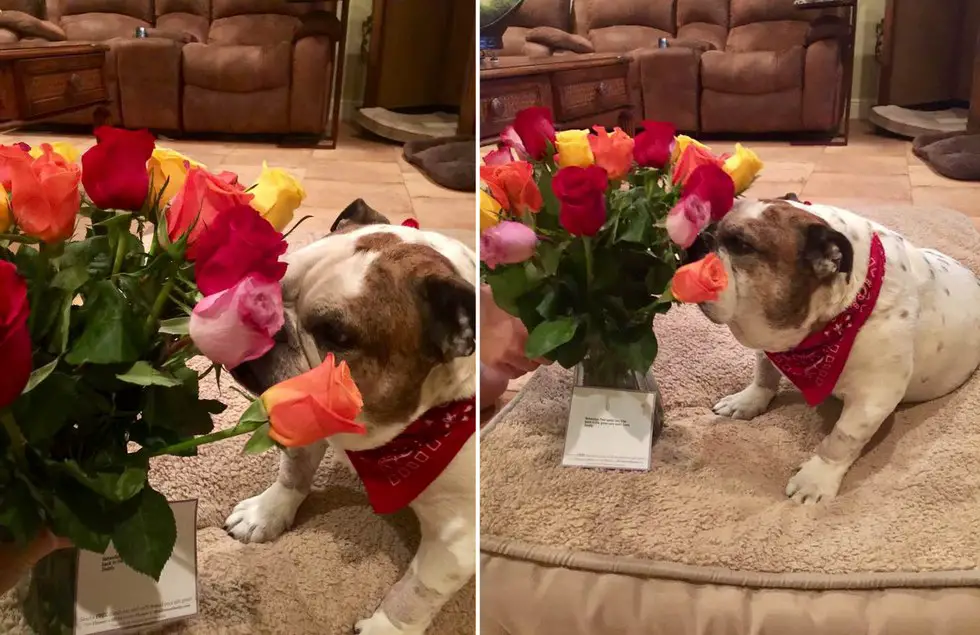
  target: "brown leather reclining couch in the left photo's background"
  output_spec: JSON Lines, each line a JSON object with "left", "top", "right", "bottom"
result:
{"left": 0, "top": 0, "right": 341, "bottom": 135}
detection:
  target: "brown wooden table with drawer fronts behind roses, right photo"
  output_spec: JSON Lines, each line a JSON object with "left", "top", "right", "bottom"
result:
{"left": 480, "top": 54, "right": 634, "bottom": 141}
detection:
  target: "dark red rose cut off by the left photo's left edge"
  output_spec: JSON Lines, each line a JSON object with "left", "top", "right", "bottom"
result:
{"left": 0, "top": 260, "right": 31, "bottom": 408}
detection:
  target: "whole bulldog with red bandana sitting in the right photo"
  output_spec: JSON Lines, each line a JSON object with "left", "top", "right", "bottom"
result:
{"left": 688, "top": 195, "right": 980, "bottom": 504}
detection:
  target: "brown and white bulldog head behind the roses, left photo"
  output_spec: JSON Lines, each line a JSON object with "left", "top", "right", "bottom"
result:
{"left": 233, "top": 200, "right": 476, "bottom": 424}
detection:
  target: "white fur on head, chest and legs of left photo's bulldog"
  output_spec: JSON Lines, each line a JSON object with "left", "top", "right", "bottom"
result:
{"left": 226, "top": 225, "right": 477, "bottom": 635}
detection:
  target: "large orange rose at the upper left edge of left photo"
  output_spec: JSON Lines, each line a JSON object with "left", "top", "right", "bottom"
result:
{"left": 0, "top": 144, "right": 82, "bottom": 243}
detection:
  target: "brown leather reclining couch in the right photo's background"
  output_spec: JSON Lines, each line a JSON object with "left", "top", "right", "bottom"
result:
{"left": 505, "top": 0, "right": 846, "bottom": 133}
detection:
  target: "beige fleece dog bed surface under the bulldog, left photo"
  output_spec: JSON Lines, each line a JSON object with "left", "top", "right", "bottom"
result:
{"left": 0, "top": 375, "right": 476, "bottom": 635}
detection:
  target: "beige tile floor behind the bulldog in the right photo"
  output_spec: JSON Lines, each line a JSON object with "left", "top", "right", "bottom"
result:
{"left": 490, "top": 122, "right": 980, "bottom": 412}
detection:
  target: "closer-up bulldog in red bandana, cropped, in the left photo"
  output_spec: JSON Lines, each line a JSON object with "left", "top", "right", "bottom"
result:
{"left": 225, "top": 200, "right": 477, "bottom": 635}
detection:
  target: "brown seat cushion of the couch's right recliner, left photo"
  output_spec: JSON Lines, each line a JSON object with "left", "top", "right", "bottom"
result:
{"left": 184, "top": 42, "right": 292, "bottom": 93}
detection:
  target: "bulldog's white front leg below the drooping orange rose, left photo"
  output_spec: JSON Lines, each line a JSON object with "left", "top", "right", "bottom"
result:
{"left": 225, "top": 441, "right": 327, "bottom": 542}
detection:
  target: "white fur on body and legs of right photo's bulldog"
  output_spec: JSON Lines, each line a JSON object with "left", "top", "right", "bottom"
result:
{"left": 705, "top": 202, "right": 980, "bottom": 503}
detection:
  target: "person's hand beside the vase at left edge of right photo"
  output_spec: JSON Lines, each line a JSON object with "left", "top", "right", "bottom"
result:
{"left": 480, "top": 285, "right": 551, "bottom": 379}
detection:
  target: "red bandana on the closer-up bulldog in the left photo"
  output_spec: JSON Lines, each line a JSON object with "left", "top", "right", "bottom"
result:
{"left": 347, "top": 397, "right": 476, "bottom": 514}
